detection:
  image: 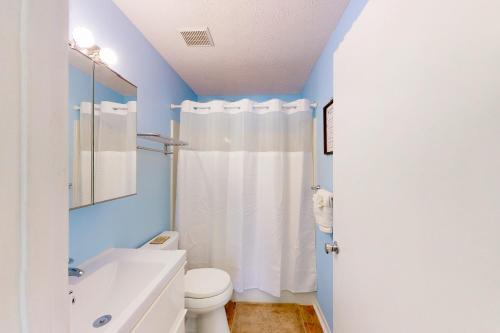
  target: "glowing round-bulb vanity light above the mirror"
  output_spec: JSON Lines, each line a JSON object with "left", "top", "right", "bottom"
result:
{"left": 69, "top": 27, "right": 118, "bottom": 65}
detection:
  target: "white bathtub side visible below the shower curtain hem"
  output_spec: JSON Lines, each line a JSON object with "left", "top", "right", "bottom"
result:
{"left": 233, "top": 289, "right": 317, "bottom": 305}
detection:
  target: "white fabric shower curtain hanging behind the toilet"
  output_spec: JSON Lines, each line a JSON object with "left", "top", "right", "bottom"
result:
{"left": 176, "top": 99, "right": 316, "bottom": 296}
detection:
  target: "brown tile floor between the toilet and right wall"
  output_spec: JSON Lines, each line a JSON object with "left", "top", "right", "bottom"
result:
{"left": 226, "top": 301, "right": 323, "bottom": 333}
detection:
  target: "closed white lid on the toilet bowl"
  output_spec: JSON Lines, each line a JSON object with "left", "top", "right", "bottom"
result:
{"left": 184, "top": 268, "right": 231, "bottom": 298}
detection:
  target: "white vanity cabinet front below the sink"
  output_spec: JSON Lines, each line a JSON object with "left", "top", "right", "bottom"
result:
{"left": 132, "top": 266, "right": 186, "bottom": 333}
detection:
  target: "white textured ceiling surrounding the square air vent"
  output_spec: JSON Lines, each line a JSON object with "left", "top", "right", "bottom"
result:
{"left": 113, "top": 0, "right": 349, "bottom": 95}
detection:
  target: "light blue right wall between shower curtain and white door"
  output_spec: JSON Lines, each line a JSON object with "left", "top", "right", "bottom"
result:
{"left": 302, "top": 0, "right": 368, "bottom": 330}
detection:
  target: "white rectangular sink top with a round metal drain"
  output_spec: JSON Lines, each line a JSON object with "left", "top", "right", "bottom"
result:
{"left": 69, "top": 249, "right": 186, "bottom": 333}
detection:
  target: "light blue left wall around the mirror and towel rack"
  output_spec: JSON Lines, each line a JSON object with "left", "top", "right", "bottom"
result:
{"left": 69, "top": 0, "right": 197, "bottom": 264}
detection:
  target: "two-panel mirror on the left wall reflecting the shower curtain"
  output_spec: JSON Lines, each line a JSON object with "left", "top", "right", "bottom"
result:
{"left": 68, "top": 48, "right": 137, "bottom": 209}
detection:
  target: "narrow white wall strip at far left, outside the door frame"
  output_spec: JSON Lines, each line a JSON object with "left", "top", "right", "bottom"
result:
{"left": 0, "top": 0, "right": 21, "bottom": 332}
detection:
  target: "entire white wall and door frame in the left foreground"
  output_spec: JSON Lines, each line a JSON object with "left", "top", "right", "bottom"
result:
{"left": 0, "top": 0, "right": 69, "bottom": 332}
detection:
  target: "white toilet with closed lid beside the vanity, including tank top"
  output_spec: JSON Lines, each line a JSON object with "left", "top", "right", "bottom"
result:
{"left": 142, "top": 231, "right": 233, "bottom": 333}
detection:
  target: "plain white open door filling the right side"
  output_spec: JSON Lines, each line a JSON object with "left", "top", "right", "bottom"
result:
{"left": 334, "top": 0, "right": 500, "bottom": 333}
